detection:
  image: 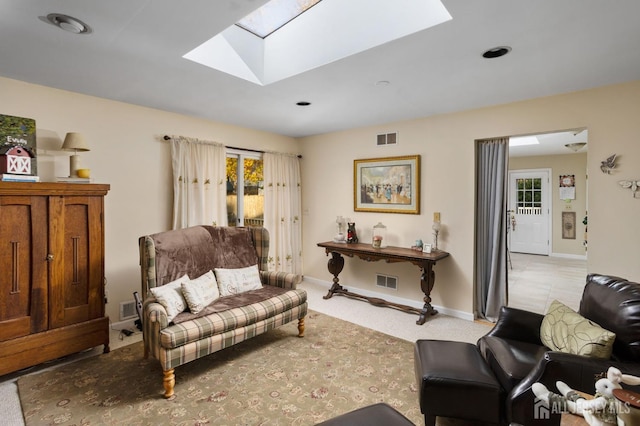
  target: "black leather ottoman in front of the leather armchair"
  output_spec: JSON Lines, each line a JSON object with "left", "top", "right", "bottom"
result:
{"left": 414, "top": 340, "right": 502, "bottom": 426}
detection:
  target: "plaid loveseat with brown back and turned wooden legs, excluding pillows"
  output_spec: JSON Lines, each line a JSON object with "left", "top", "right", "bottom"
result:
{"left": 139, "top": 226, "right": 307, "bottom": 398}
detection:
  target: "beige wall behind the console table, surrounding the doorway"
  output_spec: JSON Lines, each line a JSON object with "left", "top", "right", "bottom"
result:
{"left": 302, "top": 81, "right": 640, "bottom": 320}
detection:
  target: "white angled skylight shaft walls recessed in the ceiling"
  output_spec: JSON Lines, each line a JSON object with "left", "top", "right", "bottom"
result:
{"left": 183, "top": 0, "right": 451, "bottom": 86}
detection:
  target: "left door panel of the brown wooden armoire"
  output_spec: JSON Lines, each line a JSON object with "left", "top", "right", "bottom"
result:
{"left": 0, "top": 196, "right": 47, "bottom": 341}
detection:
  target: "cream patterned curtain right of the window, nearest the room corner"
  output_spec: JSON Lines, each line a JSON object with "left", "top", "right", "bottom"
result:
{"left": 263, "top": 153, "right": 302, "bottom": 275}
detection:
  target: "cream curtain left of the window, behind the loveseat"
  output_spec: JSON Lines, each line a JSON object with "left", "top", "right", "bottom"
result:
{"left": 171, "top": 136, "right": 227, "bottom": 229}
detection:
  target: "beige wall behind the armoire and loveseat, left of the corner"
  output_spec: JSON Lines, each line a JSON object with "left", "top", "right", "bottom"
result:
{"left": 0, "top": 78, "right": 298, "bottom": 322}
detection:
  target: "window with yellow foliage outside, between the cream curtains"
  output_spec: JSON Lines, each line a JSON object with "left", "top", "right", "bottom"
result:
{"left": 227, "top": 151, "right": 264, "bottom": 226}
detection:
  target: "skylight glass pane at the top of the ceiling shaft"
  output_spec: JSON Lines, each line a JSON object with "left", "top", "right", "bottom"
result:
{"left": 236, "top": 0, "right": 322, "bottom": 38}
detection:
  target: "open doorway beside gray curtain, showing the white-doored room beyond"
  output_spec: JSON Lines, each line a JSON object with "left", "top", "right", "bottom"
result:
{"left": 507, "top": 129, "right": 588, "bottom": 313}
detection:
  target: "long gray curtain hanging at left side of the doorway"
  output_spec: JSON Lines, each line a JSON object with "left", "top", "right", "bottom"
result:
{"left": 475, "top": 138, "right": 509, "bottom": 322}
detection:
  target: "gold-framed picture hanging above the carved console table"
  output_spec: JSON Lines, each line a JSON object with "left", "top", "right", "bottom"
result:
{"left": 353, "top": 155, "right": 420, "bottom": 214}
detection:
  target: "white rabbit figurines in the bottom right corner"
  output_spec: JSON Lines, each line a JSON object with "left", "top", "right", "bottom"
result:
{"left": 531, "top": 367, "right": 640, "bottom": 426}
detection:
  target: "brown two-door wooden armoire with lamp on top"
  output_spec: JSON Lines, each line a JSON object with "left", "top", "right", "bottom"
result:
{"left": 0, "top": 182, "right": 109, "bottom": 375}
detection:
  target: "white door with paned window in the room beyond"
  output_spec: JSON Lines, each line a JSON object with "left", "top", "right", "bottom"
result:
{"left": 507, "top": 169, "right": 551, "bottom": 255}
